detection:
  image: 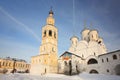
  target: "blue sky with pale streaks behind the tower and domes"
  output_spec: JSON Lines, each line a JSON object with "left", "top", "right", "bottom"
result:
{"left": 0, "top": 0, "right": 120, "bottom": 61}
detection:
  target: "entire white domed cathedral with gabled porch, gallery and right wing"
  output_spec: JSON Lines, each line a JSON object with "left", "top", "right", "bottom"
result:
{"left": 58, "top": 28, "right": 120, "bottom": 75}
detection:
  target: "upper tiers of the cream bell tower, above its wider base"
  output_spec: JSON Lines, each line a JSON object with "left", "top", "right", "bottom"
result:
{"left": 40, "top": 10, "right": 58, "bottom": 54}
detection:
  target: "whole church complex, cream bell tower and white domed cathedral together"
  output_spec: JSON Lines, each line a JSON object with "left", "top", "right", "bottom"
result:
{"left": 30, "top": 10, "right": 120, "bottom": 75}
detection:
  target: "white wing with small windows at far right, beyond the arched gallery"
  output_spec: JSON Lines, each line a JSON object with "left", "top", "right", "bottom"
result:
{"left": 99, "top": 51, "right": 120, "bottom": 74}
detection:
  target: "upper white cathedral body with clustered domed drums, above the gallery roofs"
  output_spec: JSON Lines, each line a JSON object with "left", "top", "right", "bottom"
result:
{"left": 68, "top": 29, "right": 107, "bottom": 58}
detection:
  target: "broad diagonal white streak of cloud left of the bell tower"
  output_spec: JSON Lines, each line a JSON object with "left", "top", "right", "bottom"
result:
{"left": 0, "top": 7, "right": 40, "bottom": 42}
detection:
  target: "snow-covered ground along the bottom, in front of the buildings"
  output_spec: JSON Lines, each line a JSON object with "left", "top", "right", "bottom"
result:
{"left": 0, "top": 73, "right": 120, "bottom": 80}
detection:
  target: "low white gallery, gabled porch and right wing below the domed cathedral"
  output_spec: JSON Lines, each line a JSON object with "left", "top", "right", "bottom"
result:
{"left": 58, "top": 50, "right": 120, "bottom": 75}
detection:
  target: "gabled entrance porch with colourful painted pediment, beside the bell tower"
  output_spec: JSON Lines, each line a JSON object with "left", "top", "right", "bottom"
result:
{"left": 58, "top": 52, "right": 84, "bottom": 74}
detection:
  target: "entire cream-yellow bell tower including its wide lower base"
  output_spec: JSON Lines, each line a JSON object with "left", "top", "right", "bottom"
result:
{"left": 30, "top": 10, "right": 58, "bottom": 74}
